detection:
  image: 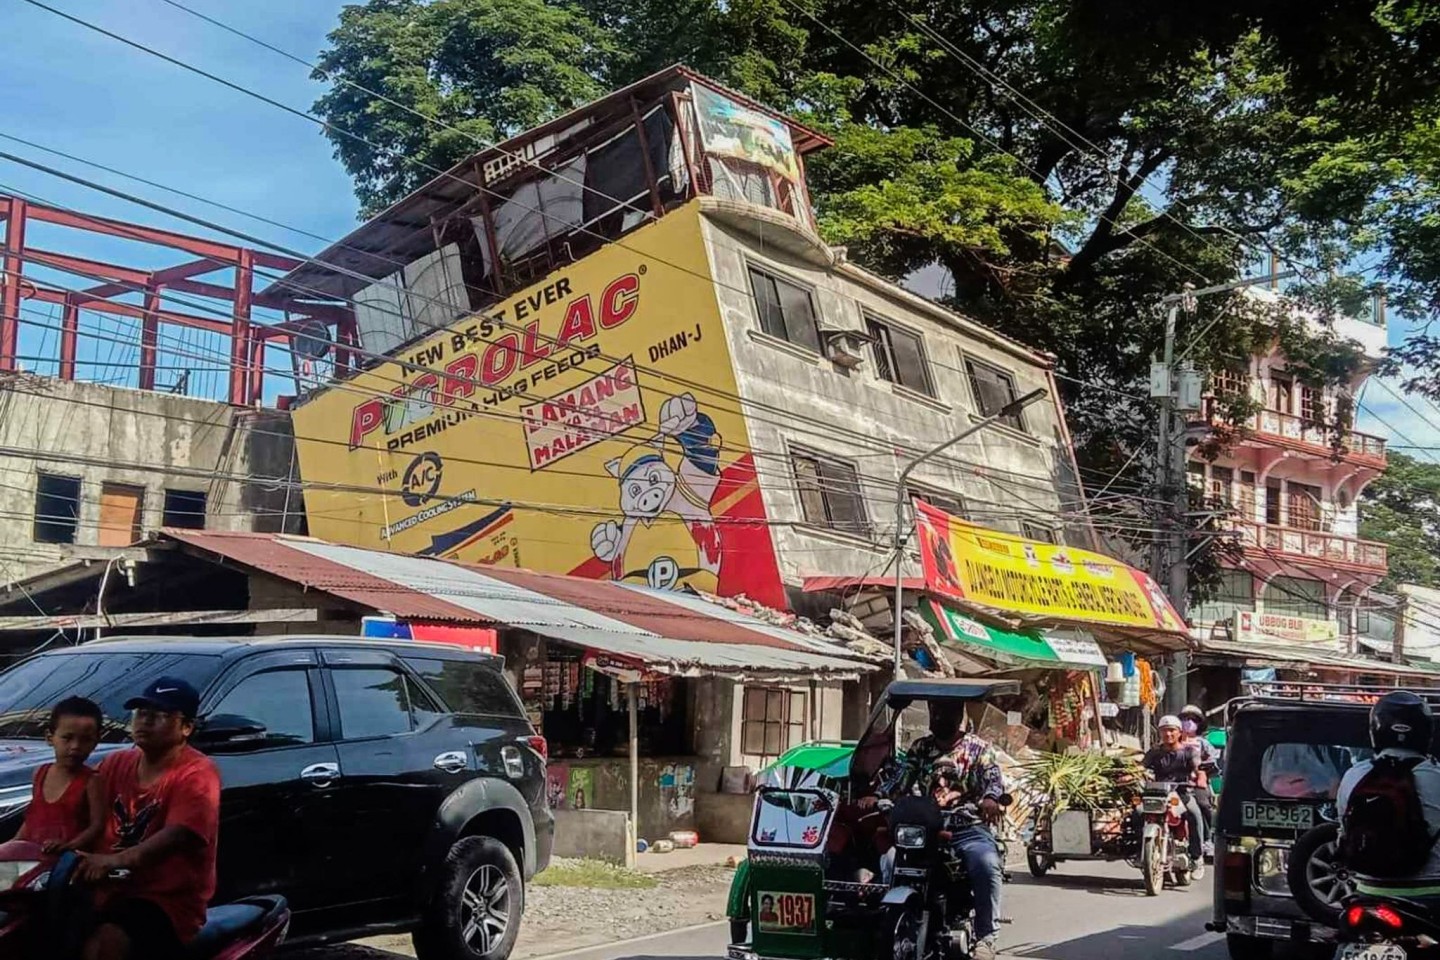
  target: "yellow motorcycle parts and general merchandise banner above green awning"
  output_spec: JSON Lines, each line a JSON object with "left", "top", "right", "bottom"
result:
{"left": 916, "top": 502, "right": 1185, "bottom": 632}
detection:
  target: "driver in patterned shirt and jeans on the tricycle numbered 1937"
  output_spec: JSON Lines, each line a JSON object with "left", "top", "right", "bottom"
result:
{"left": 883, "top": 701, "right": 1005, "bottom": 960}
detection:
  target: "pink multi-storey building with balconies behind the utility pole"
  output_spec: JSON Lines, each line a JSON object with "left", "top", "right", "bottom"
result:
{"left": 1189, "top": 291, "right": 1387, "bottom": 652}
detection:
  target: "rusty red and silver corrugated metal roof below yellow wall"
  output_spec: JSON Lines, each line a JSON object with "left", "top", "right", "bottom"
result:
{"left": 164, "top": 530, "right": 873, "bottom": 675}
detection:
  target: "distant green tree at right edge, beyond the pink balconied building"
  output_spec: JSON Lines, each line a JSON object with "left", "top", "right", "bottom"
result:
{"left": 1359, "top": 452, "right": 1440, "bottom": 592}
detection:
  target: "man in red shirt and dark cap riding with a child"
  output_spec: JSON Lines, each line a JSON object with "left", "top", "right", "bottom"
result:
{"left": 79, "top": 676, "right": 220, "bottom": 960}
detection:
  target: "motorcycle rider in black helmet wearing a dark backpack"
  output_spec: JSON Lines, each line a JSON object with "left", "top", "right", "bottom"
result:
{"left": 1335, "top": 689, "right": 1440, "bottom": 910}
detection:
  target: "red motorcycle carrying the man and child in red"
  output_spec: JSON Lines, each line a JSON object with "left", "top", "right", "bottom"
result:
{"left": 0, "top": 841, "right": 289, "bottom": 960}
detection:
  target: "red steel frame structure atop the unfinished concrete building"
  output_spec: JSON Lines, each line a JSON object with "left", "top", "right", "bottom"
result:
{"left": 0, "top": 194, "right": 360, "bottom": 406}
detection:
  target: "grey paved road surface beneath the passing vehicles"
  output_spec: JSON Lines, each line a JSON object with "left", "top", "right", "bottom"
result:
{"left": 535, "top": 864, "right": 1225, "bottom": 960}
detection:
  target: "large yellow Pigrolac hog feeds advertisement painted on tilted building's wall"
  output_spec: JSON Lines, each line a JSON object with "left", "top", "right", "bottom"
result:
{"left": 294, "top": 204, "right": 785, "bottom": 606}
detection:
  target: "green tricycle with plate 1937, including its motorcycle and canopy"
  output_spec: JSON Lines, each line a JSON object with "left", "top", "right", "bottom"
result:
{"left": 727, "top": 679, "right": 1020, "bottom": 960}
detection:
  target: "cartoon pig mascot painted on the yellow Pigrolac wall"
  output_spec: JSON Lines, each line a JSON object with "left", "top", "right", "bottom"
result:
{"left": 590, "top": 393, "right": 720, "bottom": 593}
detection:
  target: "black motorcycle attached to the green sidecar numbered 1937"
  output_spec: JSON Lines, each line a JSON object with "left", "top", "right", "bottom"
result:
{"left": 883, "top": 796, "right": 1011, "bottom": 960}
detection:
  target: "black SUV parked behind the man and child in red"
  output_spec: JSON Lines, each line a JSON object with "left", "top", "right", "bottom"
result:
{"left": 0, "top": 636, "right": 554, "bottom": 960}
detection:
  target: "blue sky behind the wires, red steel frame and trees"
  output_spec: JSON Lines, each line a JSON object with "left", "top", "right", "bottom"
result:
{"left": 0, "top": 0, "right": 1440, "bottom": 462}
